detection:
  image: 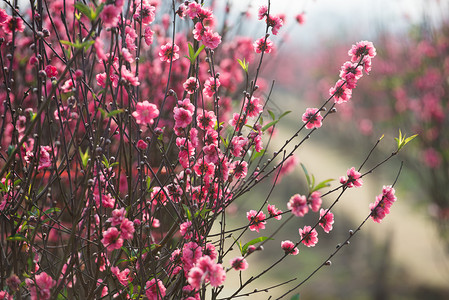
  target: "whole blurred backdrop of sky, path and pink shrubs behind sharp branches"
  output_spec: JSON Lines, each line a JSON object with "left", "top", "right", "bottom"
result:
{"left": 222, "top": 0, "right": 449, "bottom": 299}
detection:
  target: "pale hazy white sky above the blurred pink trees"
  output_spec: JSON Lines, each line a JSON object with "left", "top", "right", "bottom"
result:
{"left": 229, "top": 0, "right": 449, "bottom": 46}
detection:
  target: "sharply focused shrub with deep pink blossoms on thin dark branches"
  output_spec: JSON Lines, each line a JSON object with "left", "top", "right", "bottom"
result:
{"left": 0, "top": 0, "right": 406, "bottom": 300}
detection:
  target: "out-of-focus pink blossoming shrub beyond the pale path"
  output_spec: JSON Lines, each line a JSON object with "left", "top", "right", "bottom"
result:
{"left": 304, "top": 13, "right": 449, "bottom": 248}
